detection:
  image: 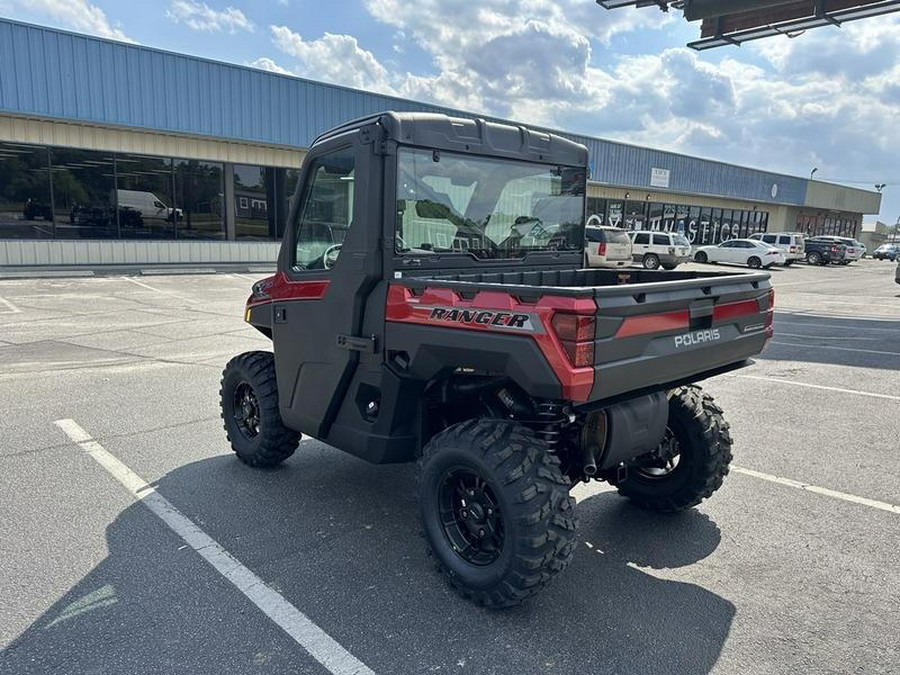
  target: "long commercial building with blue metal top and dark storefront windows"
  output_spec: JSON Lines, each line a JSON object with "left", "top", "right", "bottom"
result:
{"left": 0, "top": 20, "right": 880, "bottom": 266}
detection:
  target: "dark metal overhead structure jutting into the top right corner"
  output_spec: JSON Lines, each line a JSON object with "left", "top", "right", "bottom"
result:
{"left": 597, "top": 0, "right": 900, "bottom": 50}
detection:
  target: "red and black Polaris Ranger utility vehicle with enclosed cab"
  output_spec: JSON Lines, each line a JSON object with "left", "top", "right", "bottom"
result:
{"left": 221, "top": 113, "right": 773, "bottom": 607}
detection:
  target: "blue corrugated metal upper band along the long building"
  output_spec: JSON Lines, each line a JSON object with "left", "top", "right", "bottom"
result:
{"left": 0, "top": 19, "right": 807, "bottom": 205}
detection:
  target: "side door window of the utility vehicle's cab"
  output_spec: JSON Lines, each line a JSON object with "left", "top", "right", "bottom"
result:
{"left": 293, "top": 148, "right": 356, "bottom": 270}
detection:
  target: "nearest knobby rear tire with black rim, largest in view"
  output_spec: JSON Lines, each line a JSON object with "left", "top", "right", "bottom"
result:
{"left": 419, "top": 420, "right": 577, "bottom": 608}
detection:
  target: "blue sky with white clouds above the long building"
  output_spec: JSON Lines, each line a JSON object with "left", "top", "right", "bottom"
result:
{"left": 0, "top": 0, "right": 900, "bottom": 224}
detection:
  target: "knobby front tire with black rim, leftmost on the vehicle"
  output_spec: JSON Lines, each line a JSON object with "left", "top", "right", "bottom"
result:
{"left": 219, "top": 352, "right": 300, "bottom": 467}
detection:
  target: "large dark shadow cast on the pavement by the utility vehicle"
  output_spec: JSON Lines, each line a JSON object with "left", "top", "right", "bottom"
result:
{"left": 0, "top": 441, "right": 735, "bottom": 675}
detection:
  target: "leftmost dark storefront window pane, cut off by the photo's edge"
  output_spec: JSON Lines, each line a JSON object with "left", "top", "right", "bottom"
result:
{"left": 0, "top": 143, "right": 54, "bottom": 239}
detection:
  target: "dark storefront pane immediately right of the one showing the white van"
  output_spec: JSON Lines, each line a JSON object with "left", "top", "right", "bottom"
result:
{"left": 175, "top": 159, "right": 225, "bottom": 239}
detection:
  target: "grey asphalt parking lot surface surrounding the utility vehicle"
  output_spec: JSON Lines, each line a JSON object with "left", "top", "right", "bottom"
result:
{"left": 0, "top": 260, "right": 900, "bottom": 675}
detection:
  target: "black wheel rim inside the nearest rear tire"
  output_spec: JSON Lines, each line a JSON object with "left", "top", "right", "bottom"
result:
{"left": 438, "top": 466, "right": 504, "bottom": 567}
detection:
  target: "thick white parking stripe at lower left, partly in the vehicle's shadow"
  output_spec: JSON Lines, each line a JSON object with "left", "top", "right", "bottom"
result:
{"left": 55, "top": 419, "right": 374, "bottom": 675}
